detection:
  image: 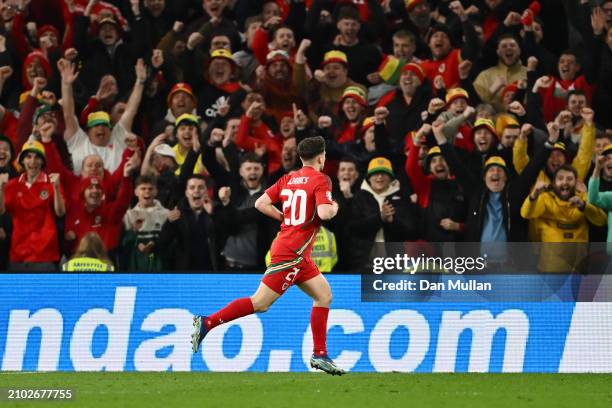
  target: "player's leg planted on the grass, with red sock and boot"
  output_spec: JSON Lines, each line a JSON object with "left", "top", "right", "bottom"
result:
{"left": 298, "top": 266, "right": 345, "bottom": 375}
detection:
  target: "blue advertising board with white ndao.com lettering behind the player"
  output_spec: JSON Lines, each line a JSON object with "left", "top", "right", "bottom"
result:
{"left": 0, "top": 274, "right": 612, "bottom": 372}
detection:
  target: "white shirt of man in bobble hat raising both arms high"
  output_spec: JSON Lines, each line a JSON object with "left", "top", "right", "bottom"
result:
{"left": 66, "top": 123, "right": 128, "bottom": 175}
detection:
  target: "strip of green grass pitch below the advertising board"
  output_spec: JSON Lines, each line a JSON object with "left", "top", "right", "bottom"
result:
{"left": 0, "top": 372, "right": 612, "bottom": 408}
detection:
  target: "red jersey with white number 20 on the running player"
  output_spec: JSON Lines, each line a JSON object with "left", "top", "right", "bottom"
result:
{"left": 266, "top": 167, "right": 333, "bottom": 258}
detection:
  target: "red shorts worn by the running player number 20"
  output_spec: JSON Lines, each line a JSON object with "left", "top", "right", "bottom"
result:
{"left": 261, "top": 257, "right": 321, "bottom": 295}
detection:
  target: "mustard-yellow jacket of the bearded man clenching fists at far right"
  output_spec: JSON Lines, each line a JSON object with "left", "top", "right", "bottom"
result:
{"left": 521, "top": 191, "right": 607, "bottom": 273}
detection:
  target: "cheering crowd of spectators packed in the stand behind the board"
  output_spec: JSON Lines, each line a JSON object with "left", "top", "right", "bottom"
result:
{"left": 0, "top": 0, "right": 612, "bottom": 271}
